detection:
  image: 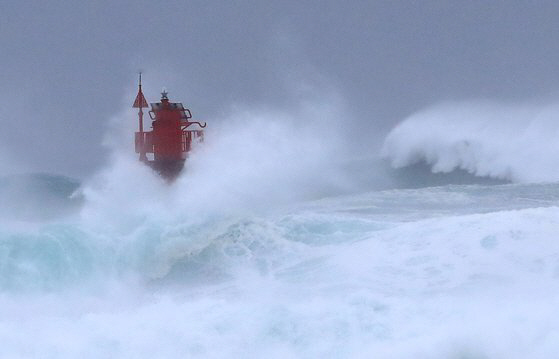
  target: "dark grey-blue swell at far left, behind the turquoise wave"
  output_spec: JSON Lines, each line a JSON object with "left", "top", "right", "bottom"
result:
{"left": 0, "top": 173, "right": 83, "bottom": 220}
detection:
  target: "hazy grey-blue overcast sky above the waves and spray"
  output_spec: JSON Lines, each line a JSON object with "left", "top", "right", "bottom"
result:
{"left": 0, "top": 0, "right": 559, "bottom": 177}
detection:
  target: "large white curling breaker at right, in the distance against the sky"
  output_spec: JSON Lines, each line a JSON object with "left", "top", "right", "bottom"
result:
{"left": 382, "top": 102, "right": 559, "bottom": 182}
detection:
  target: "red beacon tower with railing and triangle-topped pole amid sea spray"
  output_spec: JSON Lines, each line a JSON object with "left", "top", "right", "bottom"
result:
{"left": 132, "top": 73, "right": 206, "bottom": 181}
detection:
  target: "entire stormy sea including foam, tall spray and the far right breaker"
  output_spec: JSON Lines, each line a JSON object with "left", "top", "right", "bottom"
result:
{"left": 0, "top": 104, "right": 559, "bottom": 359}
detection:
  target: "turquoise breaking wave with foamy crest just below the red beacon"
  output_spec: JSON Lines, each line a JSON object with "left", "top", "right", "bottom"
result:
{"left": 0, "top": 210, "right": 382, "bottom": 292}
